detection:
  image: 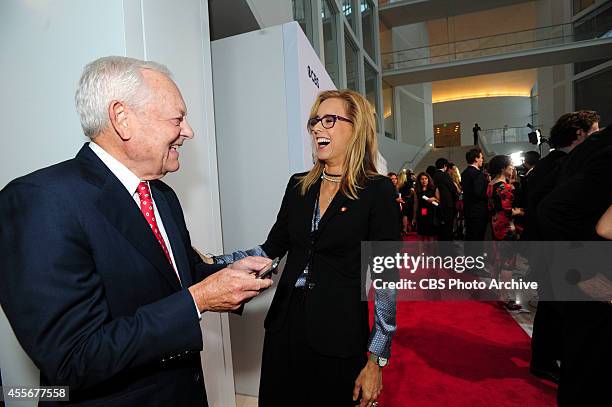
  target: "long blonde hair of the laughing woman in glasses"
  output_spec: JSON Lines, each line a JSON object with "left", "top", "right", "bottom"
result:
{"left": 299, "top": 89, "right": 378, "bottom": 199}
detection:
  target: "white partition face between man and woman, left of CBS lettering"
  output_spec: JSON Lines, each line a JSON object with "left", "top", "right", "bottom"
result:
{"left": 212, "top": 27, "right": 289, "bottom": 396}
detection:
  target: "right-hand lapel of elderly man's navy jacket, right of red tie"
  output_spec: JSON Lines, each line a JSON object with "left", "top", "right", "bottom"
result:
{"left": 149, "top": 182, "right": 193, "bottom": 287}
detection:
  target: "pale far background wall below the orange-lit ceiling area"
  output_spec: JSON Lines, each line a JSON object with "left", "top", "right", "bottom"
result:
{"left": 433, "top": 96, "right": 531, "bottom": 146}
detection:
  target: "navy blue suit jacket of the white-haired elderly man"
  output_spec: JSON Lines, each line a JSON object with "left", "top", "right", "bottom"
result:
{"left": 0, "top": 144, "right": 221, "bottom": 406}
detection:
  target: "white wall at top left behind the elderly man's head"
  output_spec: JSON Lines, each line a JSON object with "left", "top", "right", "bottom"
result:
{"left": 0, "top": 0, "right": 125, "bottom": 188}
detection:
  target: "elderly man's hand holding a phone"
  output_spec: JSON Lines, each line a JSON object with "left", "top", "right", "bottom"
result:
{"left": 189, "top": 268, "right": 272, "bottom": 312}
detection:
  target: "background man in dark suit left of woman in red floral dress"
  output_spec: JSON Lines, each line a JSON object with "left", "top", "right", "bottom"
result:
{"left": 432, "top": 158, "right": 457, "bottom": 241}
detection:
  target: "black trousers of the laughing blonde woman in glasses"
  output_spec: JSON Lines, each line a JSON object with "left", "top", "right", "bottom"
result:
{"left": 259, "top": 289, "right": 367, "bottom": 407}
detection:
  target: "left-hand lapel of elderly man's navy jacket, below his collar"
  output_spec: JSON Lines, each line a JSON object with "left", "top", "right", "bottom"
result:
{"left": 76, "top": 143, "right": 181, "bottom": 290}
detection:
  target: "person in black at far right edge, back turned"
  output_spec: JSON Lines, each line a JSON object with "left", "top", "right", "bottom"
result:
{"left": 538, "top": 123, "right": 612, "bottom": 406}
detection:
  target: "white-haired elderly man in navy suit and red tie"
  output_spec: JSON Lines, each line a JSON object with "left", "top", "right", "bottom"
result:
{"left": 0, "top": 57, "right": 271, "bottom": 406}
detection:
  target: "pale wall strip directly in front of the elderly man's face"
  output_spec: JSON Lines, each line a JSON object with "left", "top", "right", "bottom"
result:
{"left": 134, "top": 0, "right": 235, "bottom": 406}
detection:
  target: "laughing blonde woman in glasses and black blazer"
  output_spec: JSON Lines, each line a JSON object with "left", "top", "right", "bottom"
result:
{"left": 259, "top": 90, "right": 400, "bottom": 407}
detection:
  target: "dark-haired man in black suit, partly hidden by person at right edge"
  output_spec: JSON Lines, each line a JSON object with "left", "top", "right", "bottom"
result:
{"left": 524, "top": 111, "right": 600, "bottom": 382}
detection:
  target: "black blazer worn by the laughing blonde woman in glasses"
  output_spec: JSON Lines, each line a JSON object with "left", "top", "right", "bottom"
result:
{"left": 262, "top": 173, "right": 400, "bottom": 357}
